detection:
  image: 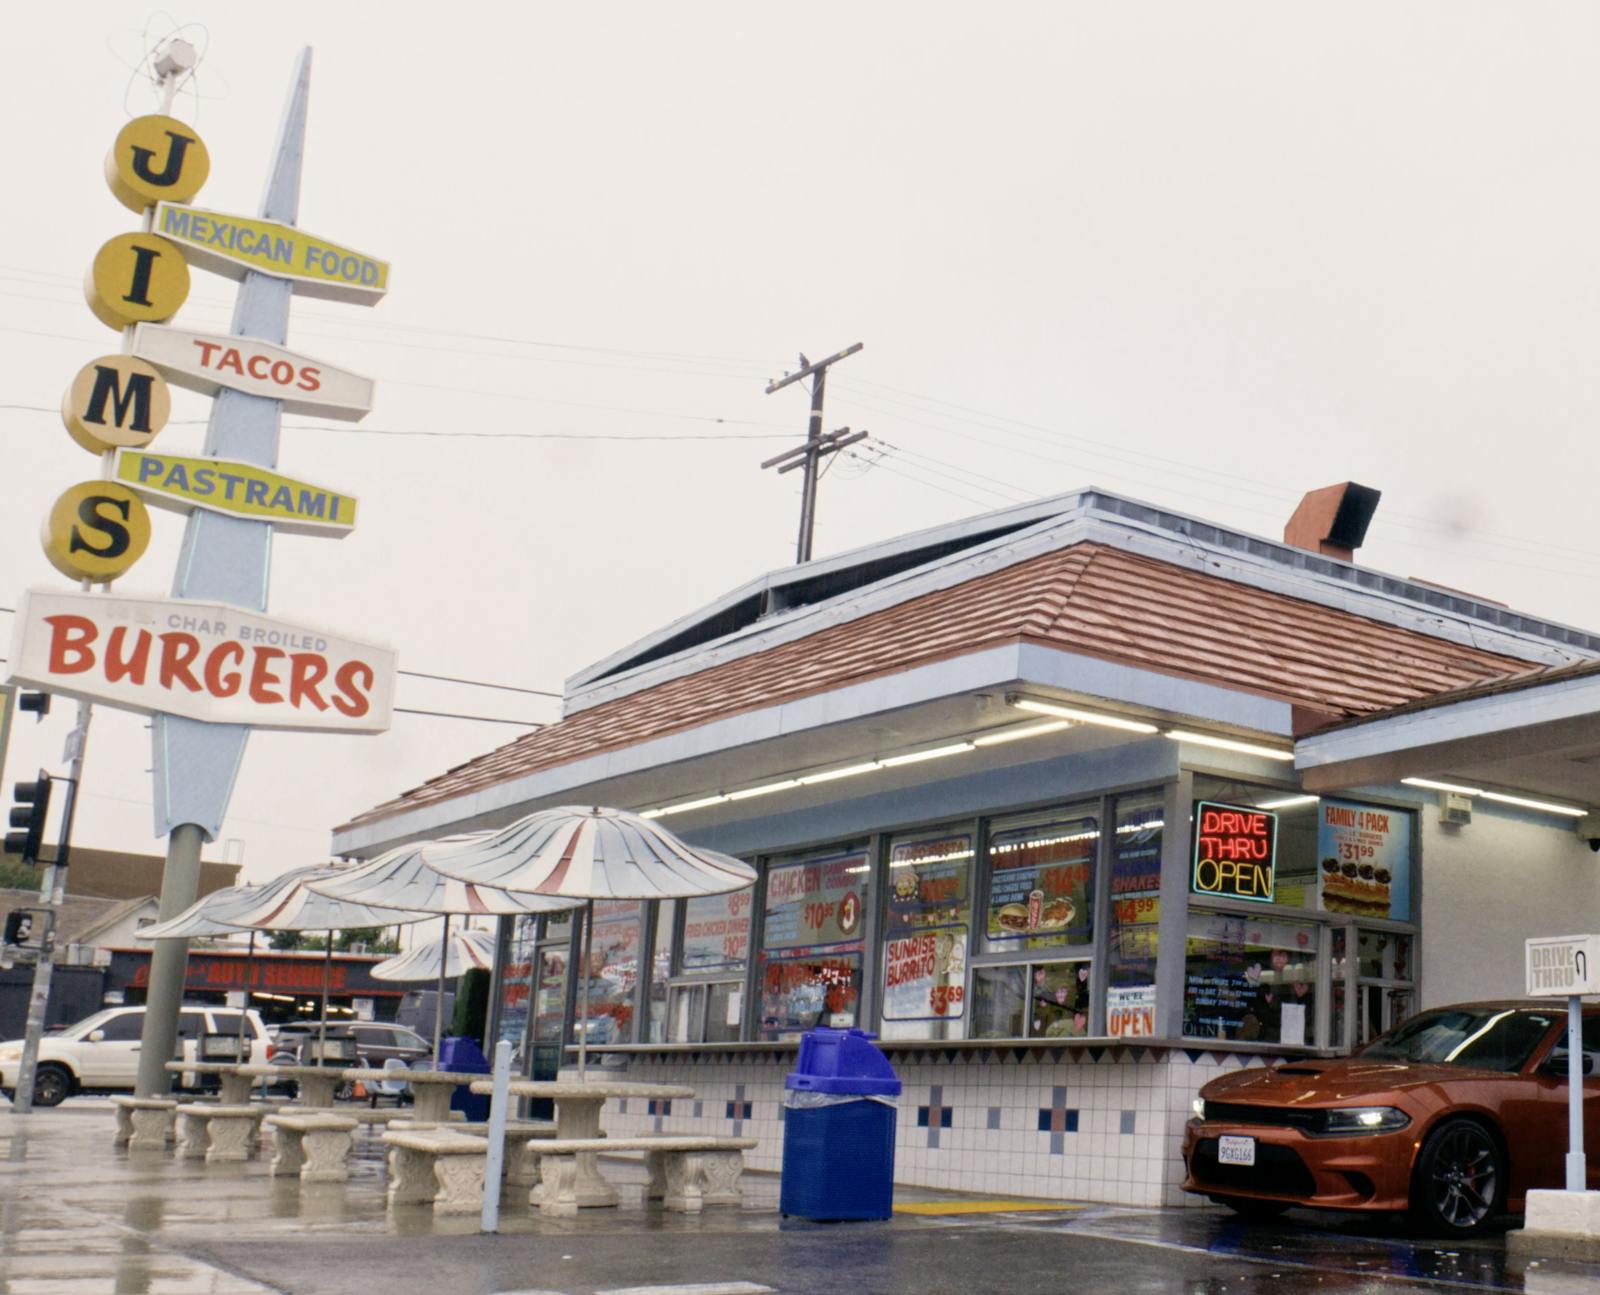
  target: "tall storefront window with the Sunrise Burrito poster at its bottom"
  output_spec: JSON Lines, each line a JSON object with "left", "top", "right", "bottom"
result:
{"left": 880, "top": 832, "right": 973, "bottom": 1039}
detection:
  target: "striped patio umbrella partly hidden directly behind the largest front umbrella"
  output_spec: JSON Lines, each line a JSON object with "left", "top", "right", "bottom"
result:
{"left": 307, "top": 832, "right": 578, "bottom": 1061}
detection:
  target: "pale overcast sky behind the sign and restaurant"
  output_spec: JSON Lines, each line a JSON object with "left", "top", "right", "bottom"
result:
{"left": 0, "top": 0, "right": 1600, "bottom": 909}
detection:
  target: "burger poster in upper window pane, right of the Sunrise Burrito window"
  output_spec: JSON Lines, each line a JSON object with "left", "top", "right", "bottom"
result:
{"left": 989, "top": 818, "right": 1099, "bottom": 944}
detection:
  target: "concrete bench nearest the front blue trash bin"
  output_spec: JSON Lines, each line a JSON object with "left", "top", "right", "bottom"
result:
{"left": 528, "top": 1135, "right": 755, "bottom": 1215}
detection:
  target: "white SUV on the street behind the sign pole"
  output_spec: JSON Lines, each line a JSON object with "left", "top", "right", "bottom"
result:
{"left": 0, "top": 1004, "right": 267, "bottom": 1106}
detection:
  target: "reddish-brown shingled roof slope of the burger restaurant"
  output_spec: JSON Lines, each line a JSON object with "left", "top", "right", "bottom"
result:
{"left": 344, "top": 543, "right": 1528, "bottom": 826}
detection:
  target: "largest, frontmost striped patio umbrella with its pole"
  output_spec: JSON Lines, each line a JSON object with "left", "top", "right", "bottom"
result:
{"left": 422, "top": 805, "right": 755, "bottom": 1076}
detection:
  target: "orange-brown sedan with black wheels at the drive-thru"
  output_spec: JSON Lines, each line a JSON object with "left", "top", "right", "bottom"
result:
{"left": 1182, "top": 1002, "right": 1600, "bottom": 1236}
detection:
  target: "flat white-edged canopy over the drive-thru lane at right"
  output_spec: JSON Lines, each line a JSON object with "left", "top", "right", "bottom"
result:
{"left": 1294, "top": 674, "right": 1600, "bottom": 807}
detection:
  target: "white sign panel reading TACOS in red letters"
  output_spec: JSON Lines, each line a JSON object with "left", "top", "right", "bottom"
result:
{"left": 133, "top": 325, "right": 373, "bottom": 423}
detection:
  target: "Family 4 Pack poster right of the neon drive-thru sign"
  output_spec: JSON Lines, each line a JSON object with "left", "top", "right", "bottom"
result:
{"left": 1317, "top": 800, "right": 1411, "bottom": 922}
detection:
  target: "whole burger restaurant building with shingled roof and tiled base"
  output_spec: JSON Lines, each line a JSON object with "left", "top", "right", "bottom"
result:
{"left": 334, "top": 485, "right": 1600, "bottom": 1204}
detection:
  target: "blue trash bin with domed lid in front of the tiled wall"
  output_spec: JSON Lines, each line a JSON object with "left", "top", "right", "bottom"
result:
{"left": 778, "top": 1028, "right": 901, "bottom": 1221}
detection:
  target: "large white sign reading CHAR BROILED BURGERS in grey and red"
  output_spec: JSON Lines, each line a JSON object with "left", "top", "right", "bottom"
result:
{"left": 10, "top": 589, "right": 395, "bottom": 733}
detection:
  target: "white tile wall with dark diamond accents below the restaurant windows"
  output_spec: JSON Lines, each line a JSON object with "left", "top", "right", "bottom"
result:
{"left": 605, "top": 1045, "right": 1270, "bottom": 1205}
